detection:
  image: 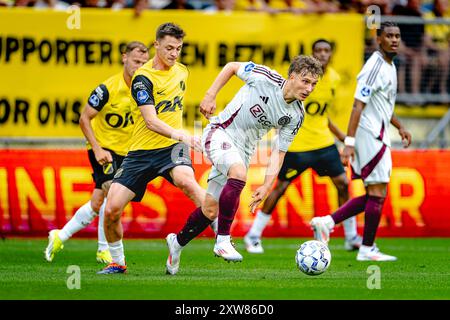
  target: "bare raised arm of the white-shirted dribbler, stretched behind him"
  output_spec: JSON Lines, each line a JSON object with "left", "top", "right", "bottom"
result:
{"left": 200, "top": 62, "right": 240, "bottom": 119}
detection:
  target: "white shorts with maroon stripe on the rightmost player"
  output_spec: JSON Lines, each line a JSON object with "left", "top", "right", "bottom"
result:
{"left": 351, "top": 128, "right": 392, "bottom": 186}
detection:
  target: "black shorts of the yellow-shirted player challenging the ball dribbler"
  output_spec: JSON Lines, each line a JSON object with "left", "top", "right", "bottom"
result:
{"left": 113, "top": 143, "right": 192, "bottom": 202}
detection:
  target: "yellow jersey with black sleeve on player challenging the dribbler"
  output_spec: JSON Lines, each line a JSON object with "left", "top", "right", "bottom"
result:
{"left": 130, "top": 59, "right": 189, "bottom": 151}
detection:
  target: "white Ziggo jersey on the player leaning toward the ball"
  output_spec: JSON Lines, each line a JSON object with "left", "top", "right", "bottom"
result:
{"left": 210, "top": 62, "right": 305, "bottom": 156}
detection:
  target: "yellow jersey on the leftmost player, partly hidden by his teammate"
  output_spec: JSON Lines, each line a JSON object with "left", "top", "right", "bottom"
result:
{"left": 88, "top": 72, "right": 134, "bottom": 156}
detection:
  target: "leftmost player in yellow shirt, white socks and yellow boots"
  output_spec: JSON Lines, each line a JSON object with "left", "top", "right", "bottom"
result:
{"left": 45, "top": 41, "right": 149, "bottom": 263}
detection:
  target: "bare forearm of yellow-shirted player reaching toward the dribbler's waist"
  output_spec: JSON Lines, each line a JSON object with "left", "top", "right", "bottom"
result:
{"left": 139, "top": 105, "right": 202, "bottom": 152}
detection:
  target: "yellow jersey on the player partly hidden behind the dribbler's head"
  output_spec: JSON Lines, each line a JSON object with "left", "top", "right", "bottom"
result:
{"left": 289, "top": 67, "right": 340, "bottom": 152}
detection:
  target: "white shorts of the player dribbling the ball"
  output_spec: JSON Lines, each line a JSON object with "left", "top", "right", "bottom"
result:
{"left": 202, "top": 124, "right": 250, "bottom": 201}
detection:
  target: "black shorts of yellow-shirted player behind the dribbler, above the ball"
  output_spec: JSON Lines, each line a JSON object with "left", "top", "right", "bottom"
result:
{"left": 278, "top": 144, "right": 345, "bottom": 181}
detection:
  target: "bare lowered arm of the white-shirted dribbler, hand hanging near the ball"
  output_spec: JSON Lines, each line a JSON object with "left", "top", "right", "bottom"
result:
{"left": 250, "top": 149, "right": 286, "bottom": 212}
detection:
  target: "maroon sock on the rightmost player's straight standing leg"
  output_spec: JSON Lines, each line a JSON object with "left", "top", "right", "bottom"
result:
{"left": 363, "top": 196, "right": 385, "bottom": 247}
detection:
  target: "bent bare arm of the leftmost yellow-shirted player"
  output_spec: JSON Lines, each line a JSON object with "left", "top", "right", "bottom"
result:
{"left": 80, "top": 104, "right": 112, "bottom": 165}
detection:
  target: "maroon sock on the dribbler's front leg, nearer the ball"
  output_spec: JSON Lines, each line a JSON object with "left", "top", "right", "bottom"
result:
{"left": 217, "top": 178, "right": 245, "bottom": 236}
